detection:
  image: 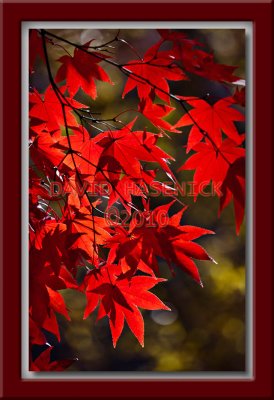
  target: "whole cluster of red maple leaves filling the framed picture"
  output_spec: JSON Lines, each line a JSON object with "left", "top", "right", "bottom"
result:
{"left": 29, "top": 30, "right": 245, "bottom": 371}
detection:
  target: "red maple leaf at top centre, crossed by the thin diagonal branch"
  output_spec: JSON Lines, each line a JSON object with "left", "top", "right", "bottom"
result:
{"left": 122, "top": 42, "right": 186, "bottom": 103}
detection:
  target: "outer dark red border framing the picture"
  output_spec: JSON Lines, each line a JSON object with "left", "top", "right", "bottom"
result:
{"left": 0, "top": 0, "right": 273, "bottom": 398}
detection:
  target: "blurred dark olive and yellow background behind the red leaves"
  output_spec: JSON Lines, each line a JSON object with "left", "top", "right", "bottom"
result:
{"left": 30, "top": 29, "right": 245, "bottom": 372}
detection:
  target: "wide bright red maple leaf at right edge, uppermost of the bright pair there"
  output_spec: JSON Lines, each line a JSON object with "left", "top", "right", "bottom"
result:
{"left": 174, "top": 97, "right": 244, "bottom": 152}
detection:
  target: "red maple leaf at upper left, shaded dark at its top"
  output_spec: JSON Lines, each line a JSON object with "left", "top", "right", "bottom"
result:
{"left": 55, "top": 41, "right": 112, "bottom": 99}
